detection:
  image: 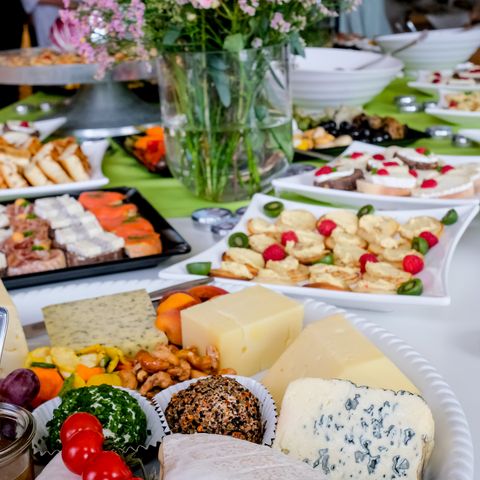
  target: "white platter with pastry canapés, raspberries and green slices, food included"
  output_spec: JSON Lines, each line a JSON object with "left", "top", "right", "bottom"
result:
{"left": 159, "top": 194, "right": 478, "bottom": 310}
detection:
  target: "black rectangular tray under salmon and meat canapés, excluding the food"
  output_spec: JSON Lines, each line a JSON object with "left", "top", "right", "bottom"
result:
{"left": 2, "top": 187, "right": 191, "bottom": 289}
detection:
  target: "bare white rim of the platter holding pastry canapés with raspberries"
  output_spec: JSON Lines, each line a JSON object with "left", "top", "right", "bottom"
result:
{"left": 159, "top": 194, "right": 478, "bottom": 311}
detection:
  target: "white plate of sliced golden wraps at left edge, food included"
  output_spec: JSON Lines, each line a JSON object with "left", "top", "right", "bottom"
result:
{"left": 0, "top": 138, "right": 108, "bottom": 200}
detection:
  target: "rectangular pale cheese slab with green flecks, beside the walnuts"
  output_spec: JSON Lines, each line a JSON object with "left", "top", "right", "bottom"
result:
{"left": 42, "top": 290, "right": 167, "bottom": 355}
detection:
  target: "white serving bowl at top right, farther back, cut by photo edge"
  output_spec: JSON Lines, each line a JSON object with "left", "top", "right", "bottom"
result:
{"left": 375, "top": 28, "right": 480, "bottom": 71}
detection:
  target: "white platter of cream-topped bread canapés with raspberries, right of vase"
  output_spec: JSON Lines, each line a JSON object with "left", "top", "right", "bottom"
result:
{"left": 273, "top": 142, "right": 480, "bottom": 210}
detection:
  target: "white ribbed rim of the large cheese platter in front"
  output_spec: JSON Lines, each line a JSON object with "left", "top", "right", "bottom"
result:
{"left": 17, "top": 280, "right": 474, "bottom": 480}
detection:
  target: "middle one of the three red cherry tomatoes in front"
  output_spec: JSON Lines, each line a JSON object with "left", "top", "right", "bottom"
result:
{"left": 62, "top": 430, "right": 103, "bottom": 475}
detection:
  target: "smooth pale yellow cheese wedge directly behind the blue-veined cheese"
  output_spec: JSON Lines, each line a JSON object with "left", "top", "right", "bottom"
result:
{"left": 262, "top": 315, "right": 418, "bottom": 408}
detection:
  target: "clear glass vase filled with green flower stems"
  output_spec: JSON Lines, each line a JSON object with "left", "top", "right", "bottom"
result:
{"left": 158, "top": 45, "right": 293, "bottom": 202}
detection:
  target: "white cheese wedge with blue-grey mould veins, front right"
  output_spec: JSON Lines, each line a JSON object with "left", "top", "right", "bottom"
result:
{"left": 273, "top": 378, "right": 434, "bottom": 480}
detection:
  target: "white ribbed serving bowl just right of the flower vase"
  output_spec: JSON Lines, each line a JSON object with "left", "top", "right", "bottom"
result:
{"left": 292, "top": 48, "right": 403, "bottom": 111}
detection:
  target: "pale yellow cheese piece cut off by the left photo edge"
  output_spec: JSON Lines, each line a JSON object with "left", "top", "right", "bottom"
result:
{"left": 0, "top": 280, "right": 28, "bottom": 378}
